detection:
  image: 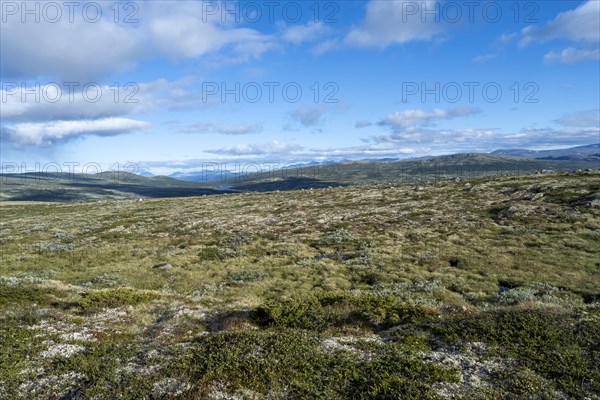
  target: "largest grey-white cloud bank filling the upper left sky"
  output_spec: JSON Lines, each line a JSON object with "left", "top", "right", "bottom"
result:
{"left": 0, "top": 1, "right": 278, "bottom": 81}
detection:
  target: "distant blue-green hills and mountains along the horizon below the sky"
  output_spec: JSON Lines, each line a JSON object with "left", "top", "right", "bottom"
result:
{"left": 0, "top": 144, "right": 600, "bottom": 202}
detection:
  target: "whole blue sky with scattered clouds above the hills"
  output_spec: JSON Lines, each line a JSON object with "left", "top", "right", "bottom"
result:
{"left": 0, "top": 0, "right": 600, "bottom": 174}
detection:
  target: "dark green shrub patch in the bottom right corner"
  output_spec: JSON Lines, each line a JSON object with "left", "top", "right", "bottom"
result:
{"left": 429, "top": 308, "right": 600, "bottom": 398}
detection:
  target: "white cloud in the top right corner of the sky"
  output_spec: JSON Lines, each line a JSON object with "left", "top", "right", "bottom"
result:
{"left": 519, "top": 0, "right": 600, "bottom": 46}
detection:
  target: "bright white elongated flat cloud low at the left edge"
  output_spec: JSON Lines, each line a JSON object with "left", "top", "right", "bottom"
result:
{"left": 2, "top": 118, "right": 150, "bottom": 146}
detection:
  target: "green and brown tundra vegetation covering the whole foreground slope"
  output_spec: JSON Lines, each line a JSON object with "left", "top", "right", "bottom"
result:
{"left": 0, "top": 172, "right": 600, "bottom": 399}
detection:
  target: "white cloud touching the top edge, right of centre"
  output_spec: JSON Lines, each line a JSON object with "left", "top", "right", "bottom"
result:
{"left": 345, "top": 0, "right": 444, "bottom": 47}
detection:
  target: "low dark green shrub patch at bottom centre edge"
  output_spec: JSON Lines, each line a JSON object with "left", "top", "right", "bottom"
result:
{"left": 181, "top": 329, "right": 456, "bottom": 399}
